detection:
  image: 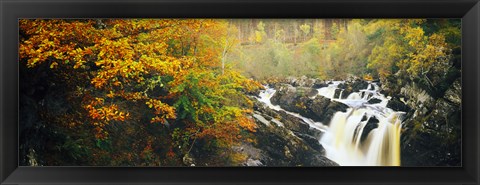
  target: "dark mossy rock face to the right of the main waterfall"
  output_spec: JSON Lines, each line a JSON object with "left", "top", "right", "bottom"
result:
{"left": 400, "top": 80, "right": 462, "bottom": 166}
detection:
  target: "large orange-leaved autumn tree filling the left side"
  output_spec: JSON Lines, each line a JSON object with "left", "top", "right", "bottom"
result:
{"left": 19, "top": 19, "right": 260, "bottom": 164}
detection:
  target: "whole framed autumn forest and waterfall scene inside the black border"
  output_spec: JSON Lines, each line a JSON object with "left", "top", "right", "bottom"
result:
{"left": 18, "top": 19, "right": 462, "bottom": 166}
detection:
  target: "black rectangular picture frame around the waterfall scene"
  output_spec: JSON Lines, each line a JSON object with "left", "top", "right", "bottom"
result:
{"left": 0, "top": 0, "right": 480, "bottom": 185}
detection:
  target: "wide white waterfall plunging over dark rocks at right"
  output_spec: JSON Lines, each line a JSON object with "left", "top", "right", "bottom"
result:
{"left": 320, "top": 81, "right": 403, "bottom": 166}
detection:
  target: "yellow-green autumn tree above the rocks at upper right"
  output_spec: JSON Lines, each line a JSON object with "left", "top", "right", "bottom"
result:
{"left": 366, "top": 19, "right": 454, "bottom": 88}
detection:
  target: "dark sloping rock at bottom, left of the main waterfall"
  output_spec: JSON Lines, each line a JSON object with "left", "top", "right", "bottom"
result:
{"left": 251, "top": 104, "right": 338, "bottom": 166}
